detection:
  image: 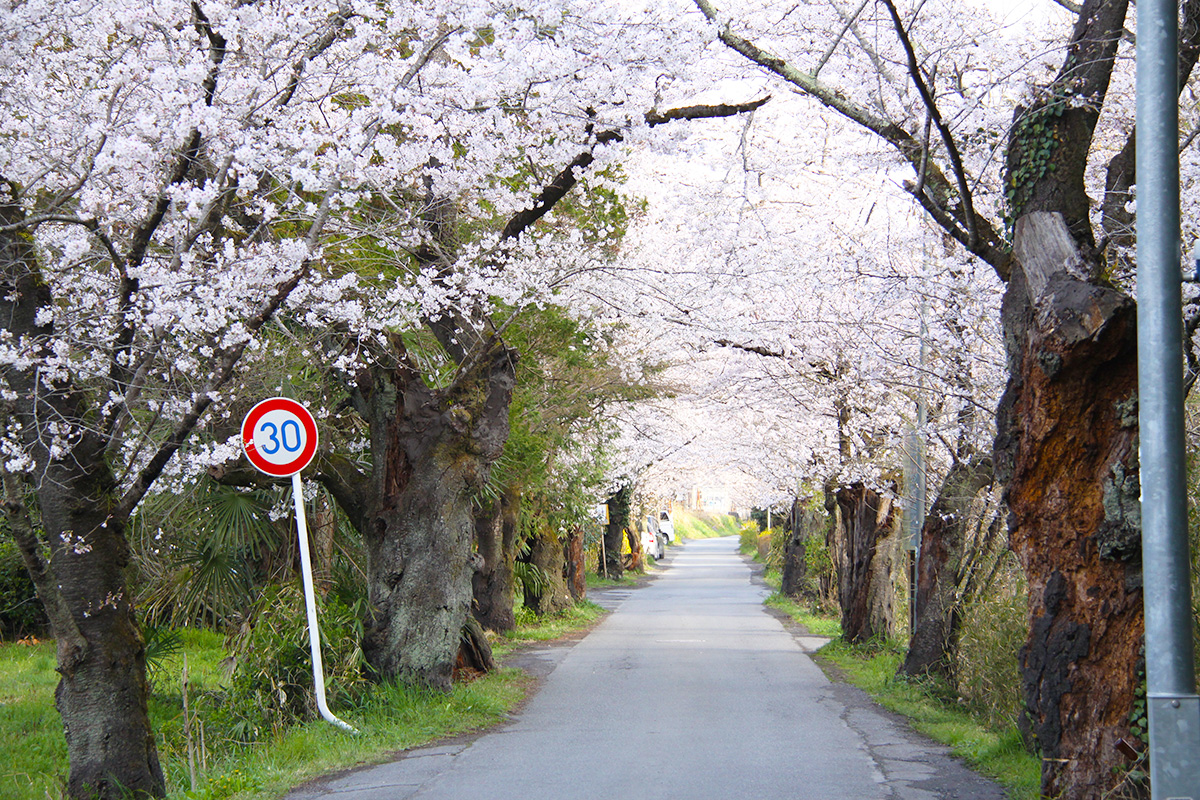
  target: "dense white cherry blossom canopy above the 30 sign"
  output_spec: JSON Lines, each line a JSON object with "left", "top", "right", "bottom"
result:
{"left": 0, "top": 0, "right": 708, "bottom": 494}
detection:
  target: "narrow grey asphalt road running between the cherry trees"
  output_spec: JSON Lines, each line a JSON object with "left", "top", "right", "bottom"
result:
{"left": 288, "top": 539, "right": 1004, "bottom": 800}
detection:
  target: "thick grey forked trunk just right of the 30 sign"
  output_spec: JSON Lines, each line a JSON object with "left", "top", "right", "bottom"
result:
{"left": 355, "top": 337, "right": 515, "bottom": 690}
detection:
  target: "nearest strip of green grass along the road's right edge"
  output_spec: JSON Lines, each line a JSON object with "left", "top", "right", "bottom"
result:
{"left": 817, "top": 639, "right": 1042, "bottom": 800}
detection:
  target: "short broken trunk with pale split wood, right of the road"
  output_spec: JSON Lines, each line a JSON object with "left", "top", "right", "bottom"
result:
{"left": 836, "top": 483, "right": 895, "bottom": 644}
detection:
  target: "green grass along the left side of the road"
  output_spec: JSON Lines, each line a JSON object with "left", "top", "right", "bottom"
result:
{"left": 0, "top": 602, "right": 604, "bottom": 800}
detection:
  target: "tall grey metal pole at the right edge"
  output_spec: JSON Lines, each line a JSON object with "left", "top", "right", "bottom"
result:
{"left": 1136, "top": 0, "right": 1200, "bottom": 800}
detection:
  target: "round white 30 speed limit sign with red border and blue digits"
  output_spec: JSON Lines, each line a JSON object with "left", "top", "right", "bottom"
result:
{"left": 241, "top": 397, "right": 317, "bottom": 477}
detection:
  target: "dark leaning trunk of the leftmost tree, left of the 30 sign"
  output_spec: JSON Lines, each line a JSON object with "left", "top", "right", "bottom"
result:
{"left": 0, "top": 204, "right": 166, "bottom": 800}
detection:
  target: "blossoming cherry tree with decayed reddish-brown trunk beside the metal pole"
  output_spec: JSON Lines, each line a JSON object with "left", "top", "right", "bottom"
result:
{"left": 676, "top": 0, "right": 1198, "bottom": 796}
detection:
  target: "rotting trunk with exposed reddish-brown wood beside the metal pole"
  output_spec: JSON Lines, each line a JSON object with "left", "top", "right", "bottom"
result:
{"left": 996, "top": 247, "right": 1142, "bottom": 798}
